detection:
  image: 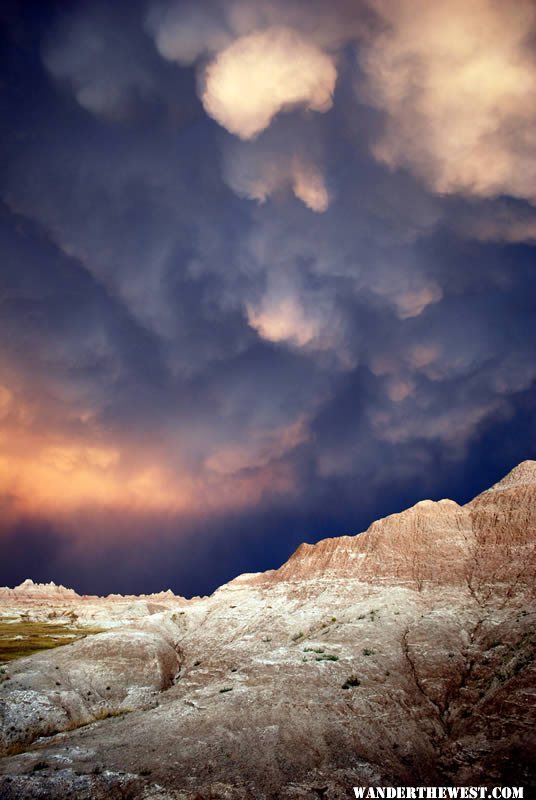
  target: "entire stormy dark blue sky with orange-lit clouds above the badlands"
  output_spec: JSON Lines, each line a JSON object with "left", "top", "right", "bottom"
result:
{"left": 0, "top": 0, "right": 536, "bottom": 596}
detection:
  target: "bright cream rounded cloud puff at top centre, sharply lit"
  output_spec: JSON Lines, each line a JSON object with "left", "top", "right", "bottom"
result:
{"left": 201, "top": 27, "right": 337, "bottom": 139}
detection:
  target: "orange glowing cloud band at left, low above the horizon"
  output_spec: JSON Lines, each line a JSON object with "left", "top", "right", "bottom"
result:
{"left": 0, "top": 372, "right": 307, "bottom": 522}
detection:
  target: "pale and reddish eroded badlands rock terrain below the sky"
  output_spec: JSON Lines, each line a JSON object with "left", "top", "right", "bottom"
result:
{"left": 0, "top": 461, "right": 536, "bottom": 800}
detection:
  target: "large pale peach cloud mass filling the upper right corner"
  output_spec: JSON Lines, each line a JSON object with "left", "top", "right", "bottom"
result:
{"left": 360, "top": 0, "right": 536, "bottom": 203}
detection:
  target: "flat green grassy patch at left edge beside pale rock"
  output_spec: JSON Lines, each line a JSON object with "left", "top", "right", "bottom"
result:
{"left": 0, "top": 620, "right": 102, "bottom": 664}
